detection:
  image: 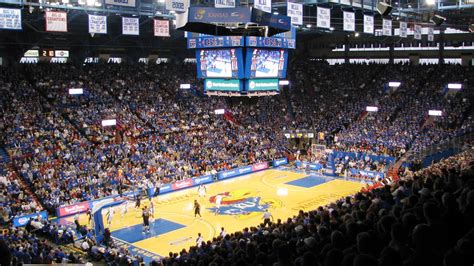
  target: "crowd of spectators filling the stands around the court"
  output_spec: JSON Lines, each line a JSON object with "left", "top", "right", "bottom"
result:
{"left": 0, "top": 61, "right": 474, "bottom": 265}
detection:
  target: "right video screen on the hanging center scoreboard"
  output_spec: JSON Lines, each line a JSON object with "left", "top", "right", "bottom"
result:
{"left": 247, "top": 49, "right": 288, "bottom": 78}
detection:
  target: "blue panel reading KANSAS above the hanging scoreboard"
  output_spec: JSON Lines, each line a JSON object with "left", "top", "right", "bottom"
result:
{"left": 188, "top": 7, "right": 251, "bottom": 23}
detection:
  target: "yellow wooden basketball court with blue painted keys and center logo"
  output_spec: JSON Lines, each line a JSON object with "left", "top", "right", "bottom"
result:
{"left": 68, "top": 169, "right": 364, "bottom": 260}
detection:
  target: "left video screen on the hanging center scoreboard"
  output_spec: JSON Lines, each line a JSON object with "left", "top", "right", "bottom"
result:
{"left": 196, "top": 49, "right": 244, "bottom": 78}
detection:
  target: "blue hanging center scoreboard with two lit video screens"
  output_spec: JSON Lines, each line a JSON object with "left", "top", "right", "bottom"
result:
{"left": 185, "top": 28, "right": 296, "bottom": 96}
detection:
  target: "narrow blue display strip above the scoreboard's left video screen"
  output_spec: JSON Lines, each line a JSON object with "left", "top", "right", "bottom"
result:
{"left": 187, "top": 36, "right": 245, "bottom": 49}
